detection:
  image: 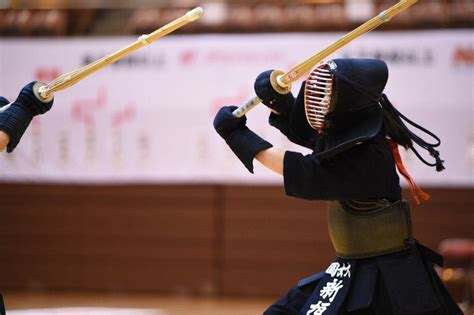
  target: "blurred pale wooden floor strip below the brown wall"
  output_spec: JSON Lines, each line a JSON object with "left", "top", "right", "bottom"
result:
{"left": 3, "top": 291, "right": 273, "bottom": 315}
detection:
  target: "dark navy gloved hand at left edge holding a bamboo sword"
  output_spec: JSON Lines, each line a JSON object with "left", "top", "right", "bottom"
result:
{"left": 0, "top": 81, "right": 53, "bottom": 152}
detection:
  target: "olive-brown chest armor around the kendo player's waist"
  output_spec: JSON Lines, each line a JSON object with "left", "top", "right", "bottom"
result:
{"left": 328, "top": 200, "right": 412, "bottom": 259}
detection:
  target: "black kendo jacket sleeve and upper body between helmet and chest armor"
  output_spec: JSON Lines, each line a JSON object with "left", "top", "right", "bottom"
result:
{"left": 283, "top": 134, "right": 401, "bottom": 201}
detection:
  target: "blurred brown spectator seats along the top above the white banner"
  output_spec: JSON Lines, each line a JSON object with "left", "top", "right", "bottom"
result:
{"left": 0, "top": 0, "right": 474, "bottom": 36}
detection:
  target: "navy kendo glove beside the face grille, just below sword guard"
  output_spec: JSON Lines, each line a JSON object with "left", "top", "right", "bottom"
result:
{"left": 254, "top": 70, "right": 295, "bottom": 117}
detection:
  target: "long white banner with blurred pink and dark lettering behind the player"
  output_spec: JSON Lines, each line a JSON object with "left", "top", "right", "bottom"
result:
{"left": 0, "top": 30, "right": 474, "bottom": 186}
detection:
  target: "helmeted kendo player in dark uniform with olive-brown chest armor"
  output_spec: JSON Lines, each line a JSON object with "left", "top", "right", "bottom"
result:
{"left": 214, "top": 59, "right": 462, "bottom": 315}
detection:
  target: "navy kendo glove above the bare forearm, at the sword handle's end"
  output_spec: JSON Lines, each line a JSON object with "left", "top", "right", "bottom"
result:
{"left": 213, "top": 106, "right": 272, "bottom": 173}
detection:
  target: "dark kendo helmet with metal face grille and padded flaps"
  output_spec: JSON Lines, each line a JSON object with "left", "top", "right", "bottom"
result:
{"left": 290, "top": 59, "right": 388, "bottom": 160}
